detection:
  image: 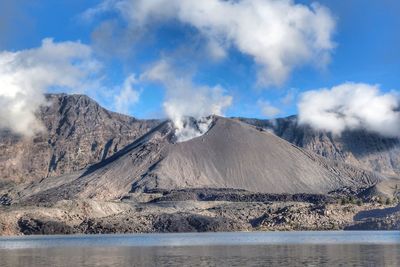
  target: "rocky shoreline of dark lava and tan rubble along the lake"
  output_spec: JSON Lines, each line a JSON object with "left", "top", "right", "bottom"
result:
{"left": 0, "top": 189, "right": 400, "bottom": 235}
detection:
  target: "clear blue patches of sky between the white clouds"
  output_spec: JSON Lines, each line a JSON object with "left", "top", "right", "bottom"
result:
{"left": 0, "top": 0, "right": 400, "bottom": 118}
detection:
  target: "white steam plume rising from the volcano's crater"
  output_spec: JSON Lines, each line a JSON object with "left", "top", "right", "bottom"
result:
{"left": 141, "top": 60, "right": 232, "bottom": 142}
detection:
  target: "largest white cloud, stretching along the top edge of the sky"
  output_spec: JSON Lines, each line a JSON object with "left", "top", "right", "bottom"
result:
{"left": 84, "top": 0, "right": 335, "bottom": 85}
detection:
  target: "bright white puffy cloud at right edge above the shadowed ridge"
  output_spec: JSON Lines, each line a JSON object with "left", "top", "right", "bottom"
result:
{"left": 298, "top": 83, "right": 400, "bottom": 137}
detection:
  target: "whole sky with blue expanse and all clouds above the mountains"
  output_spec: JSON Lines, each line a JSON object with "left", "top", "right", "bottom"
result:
{"left": 0, "top": 0, "right": 400, "bottom": 139}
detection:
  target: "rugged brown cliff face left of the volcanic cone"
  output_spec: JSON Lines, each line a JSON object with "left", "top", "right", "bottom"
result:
{"left": 0, "top": 94, "right": 158, "bottom": 182}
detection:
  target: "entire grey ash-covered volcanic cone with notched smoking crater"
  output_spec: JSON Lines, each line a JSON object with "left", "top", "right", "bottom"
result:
{"left": 22, "top": 117, "right": 383, "bottom": 201}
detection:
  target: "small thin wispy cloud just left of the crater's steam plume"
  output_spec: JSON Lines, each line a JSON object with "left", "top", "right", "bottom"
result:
{"left": 114, "top": 74, "right": 140, "bottom": 114}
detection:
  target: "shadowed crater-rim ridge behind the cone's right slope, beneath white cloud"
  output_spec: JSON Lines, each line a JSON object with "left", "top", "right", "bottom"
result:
{"left": 240, "top": 116, "right": 400, "bottom": 176}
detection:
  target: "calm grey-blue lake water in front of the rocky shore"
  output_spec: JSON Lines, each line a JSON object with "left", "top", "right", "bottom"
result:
{"left": 0, "top": 231, "right": 400, "bottom": 267}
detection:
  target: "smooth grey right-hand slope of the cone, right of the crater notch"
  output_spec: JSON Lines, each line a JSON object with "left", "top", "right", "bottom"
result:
{"left": 134, "top": 117, "right": 378, "bottom": 193}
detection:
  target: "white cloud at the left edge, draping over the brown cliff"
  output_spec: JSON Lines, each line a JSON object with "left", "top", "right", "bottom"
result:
{"left": 0, "top": 39, "right": 100, "bottom": 136}
